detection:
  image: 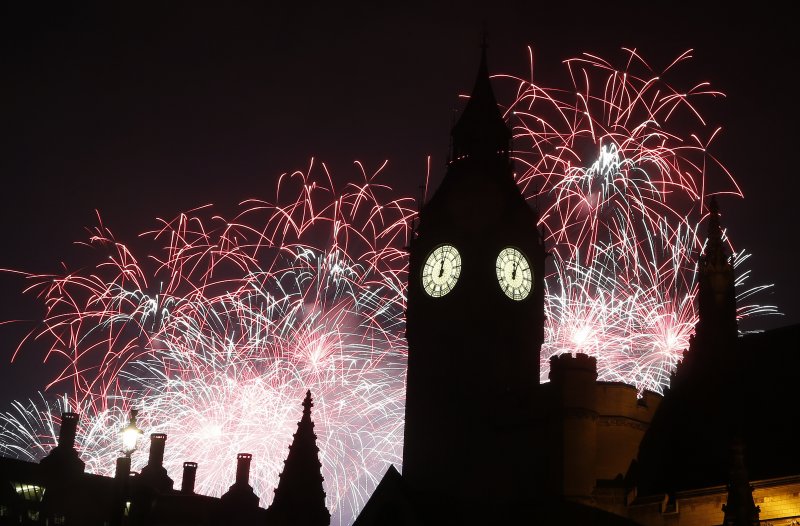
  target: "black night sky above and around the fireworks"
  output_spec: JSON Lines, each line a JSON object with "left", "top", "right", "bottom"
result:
{"left": 0, "top": 1, "right": 800, "bottom": 402}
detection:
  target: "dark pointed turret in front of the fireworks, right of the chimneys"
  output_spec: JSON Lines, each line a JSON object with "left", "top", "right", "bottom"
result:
{"left": 269, "top": 391, "right": 331, "bottom": 526}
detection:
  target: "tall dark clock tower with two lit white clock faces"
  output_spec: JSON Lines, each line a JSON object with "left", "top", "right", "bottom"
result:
{"left": 403, "top": 46, "right": 545, "bottom": 509}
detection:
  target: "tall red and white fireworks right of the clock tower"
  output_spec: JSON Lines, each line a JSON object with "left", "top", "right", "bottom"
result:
{"left": 503, "top": 50, "right": 774, "bottom": 392}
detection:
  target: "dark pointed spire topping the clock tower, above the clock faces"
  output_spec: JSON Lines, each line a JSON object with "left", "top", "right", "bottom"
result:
{"left": 451, "top": 33, "right": 511, "bottom": 161}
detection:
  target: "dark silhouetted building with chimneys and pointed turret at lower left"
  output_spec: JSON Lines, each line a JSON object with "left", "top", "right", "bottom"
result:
{"left": 0, "top": 391, "right": 330, "bottom": 526}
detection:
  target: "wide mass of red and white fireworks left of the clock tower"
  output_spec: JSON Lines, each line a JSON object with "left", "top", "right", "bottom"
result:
{"left": 3, "top": 165, "right": 412, "bottom": 521}
